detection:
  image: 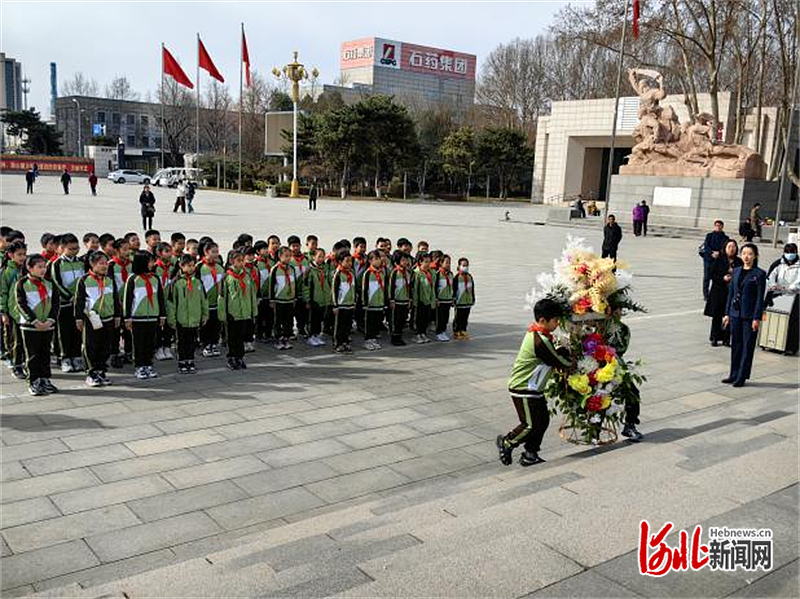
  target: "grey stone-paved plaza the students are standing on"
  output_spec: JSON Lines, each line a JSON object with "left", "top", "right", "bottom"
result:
{"left": 0, "top": 176, "right": 800, "bottom": 598}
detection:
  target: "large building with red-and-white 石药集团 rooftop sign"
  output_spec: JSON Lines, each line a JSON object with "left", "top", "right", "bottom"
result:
{"left": 323, "top": 37, "right": 476, "bottom": 112}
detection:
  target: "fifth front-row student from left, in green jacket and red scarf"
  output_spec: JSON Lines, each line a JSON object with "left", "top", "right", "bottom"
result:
{"left": 217, "top": 250, "right": 258, "bottom": 370}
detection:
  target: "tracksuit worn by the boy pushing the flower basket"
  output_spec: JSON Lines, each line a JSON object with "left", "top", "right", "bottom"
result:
{"left": 503, "top": 325, "right": 570, "bottom": 453}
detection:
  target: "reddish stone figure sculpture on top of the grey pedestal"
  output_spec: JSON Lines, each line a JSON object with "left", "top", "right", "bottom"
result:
{"left": 619, "top": 69, "right": 767, "bottom": 179}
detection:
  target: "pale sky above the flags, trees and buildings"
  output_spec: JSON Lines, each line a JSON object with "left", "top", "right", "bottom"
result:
{"left": 0, "top": 0, "right": 567, "bottom": 117}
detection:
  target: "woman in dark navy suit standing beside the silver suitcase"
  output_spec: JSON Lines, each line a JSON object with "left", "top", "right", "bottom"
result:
{"left": 722, "top": 243, "right": 767, "bottom": 387}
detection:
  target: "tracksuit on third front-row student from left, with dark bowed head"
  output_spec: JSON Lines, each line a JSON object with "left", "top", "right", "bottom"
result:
{"left": 123, "top": 273, "right": 167, "bottom": 368}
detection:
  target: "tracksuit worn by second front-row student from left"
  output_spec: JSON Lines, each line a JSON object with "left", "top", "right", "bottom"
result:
{"left": 74, "top": 271, "right": 122, "bottom": 376}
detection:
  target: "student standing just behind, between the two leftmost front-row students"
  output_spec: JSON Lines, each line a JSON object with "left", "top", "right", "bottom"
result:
{"left": 50, "top": 233, "right": 84, "bottom": 372}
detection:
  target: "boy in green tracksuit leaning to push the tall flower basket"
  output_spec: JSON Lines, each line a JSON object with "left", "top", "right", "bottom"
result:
{"left": 496, "top": 298, "right": 571, "bottom": 466}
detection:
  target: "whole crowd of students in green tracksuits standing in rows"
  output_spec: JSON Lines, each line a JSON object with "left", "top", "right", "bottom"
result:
{"left": 0, "top": 227, "right": 475, "bottom": 395}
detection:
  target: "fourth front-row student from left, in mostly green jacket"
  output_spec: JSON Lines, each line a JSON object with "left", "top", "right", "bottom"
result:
{"left": 167, "top": 254, "right": 208, "bottom": 374}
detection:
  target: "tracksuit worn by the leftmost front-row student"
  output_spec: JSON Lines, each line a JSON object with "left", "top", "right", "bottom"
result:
{"left": 14, "top": 275, "right": 59, "bottom": 383}
